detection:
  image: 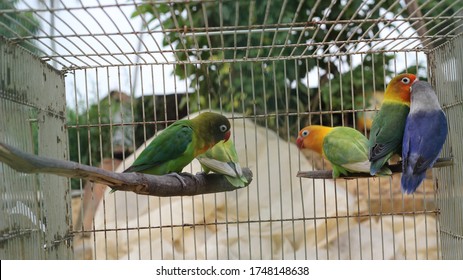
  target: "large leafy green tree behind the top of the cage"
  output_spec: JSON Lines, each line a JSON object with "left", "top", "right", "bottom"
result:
{"left": 133, "top": 0, "right": 456, "bottom": 138}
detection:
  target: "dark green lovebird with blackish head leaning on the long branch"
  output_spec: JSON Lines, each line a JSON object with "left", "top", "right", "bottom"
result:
{"left": 124, "top": 112, "right": 230, "bottom": 175}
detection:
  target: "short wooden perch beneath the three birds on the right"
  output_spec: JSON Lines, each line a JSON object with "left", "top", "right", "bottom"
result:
{"left": 297, "top": 158, "right": 453, "bottom": 180}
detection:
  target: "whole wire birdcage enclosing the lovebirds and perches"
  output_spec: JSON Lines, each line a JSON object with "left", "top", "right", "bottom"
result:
{"left": 0, "top": 0, "right": 463, "bottom": 259}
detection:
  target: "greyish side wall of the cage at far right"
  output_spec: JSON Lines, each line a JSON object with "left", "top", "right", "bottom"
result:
{"left": 429, "top": 33, "right": 463, "bottom": 259}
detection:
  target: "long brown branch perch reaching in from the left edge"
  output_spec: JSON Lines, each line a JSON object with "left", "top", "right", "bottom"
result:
{"left": 0, "top": 143, "right": 252, "bottom": 196}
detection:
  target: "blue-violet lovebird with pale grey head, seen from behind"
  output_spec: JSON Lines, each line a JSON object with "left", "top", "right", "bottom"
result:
{"left": 401, "top": 81, "right": 448, "bottom": 194}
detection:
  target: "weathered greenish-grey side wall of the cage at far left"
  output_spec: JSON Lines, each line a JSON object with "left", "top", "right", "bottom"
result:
{"left": 0, "top": 38, "right": 72, "bottom": 259}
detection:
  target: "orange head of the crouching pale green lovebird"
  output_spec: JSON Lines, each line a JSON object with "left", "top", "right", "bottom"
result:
{"left": 296, "top": 125, "right": 333, "bottom": 155}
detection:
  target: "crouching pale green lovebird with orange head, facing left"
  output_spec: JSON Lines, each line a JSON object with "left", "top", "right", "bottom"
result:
{"left": 296, "top": 125, "right": 391, "bottom": 178}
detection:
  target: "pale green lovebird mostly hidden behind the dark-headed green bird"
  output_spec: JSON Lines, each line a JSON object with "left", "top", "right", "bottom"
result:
{"left": 197, "top": 139, "right": 248, "bottom": 188}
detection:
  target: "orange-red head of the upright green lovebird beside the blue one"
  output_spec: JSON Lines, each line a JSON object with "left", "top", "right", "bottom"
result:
{"left": 384, "top": 73, "right": 418, "bottom": 104}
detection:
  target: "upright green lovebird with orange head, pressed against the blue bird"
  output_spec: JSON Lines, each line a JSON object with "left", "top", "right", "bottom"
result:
{"left": 368, "top": 74, "right": 417, "bottom": 175}
